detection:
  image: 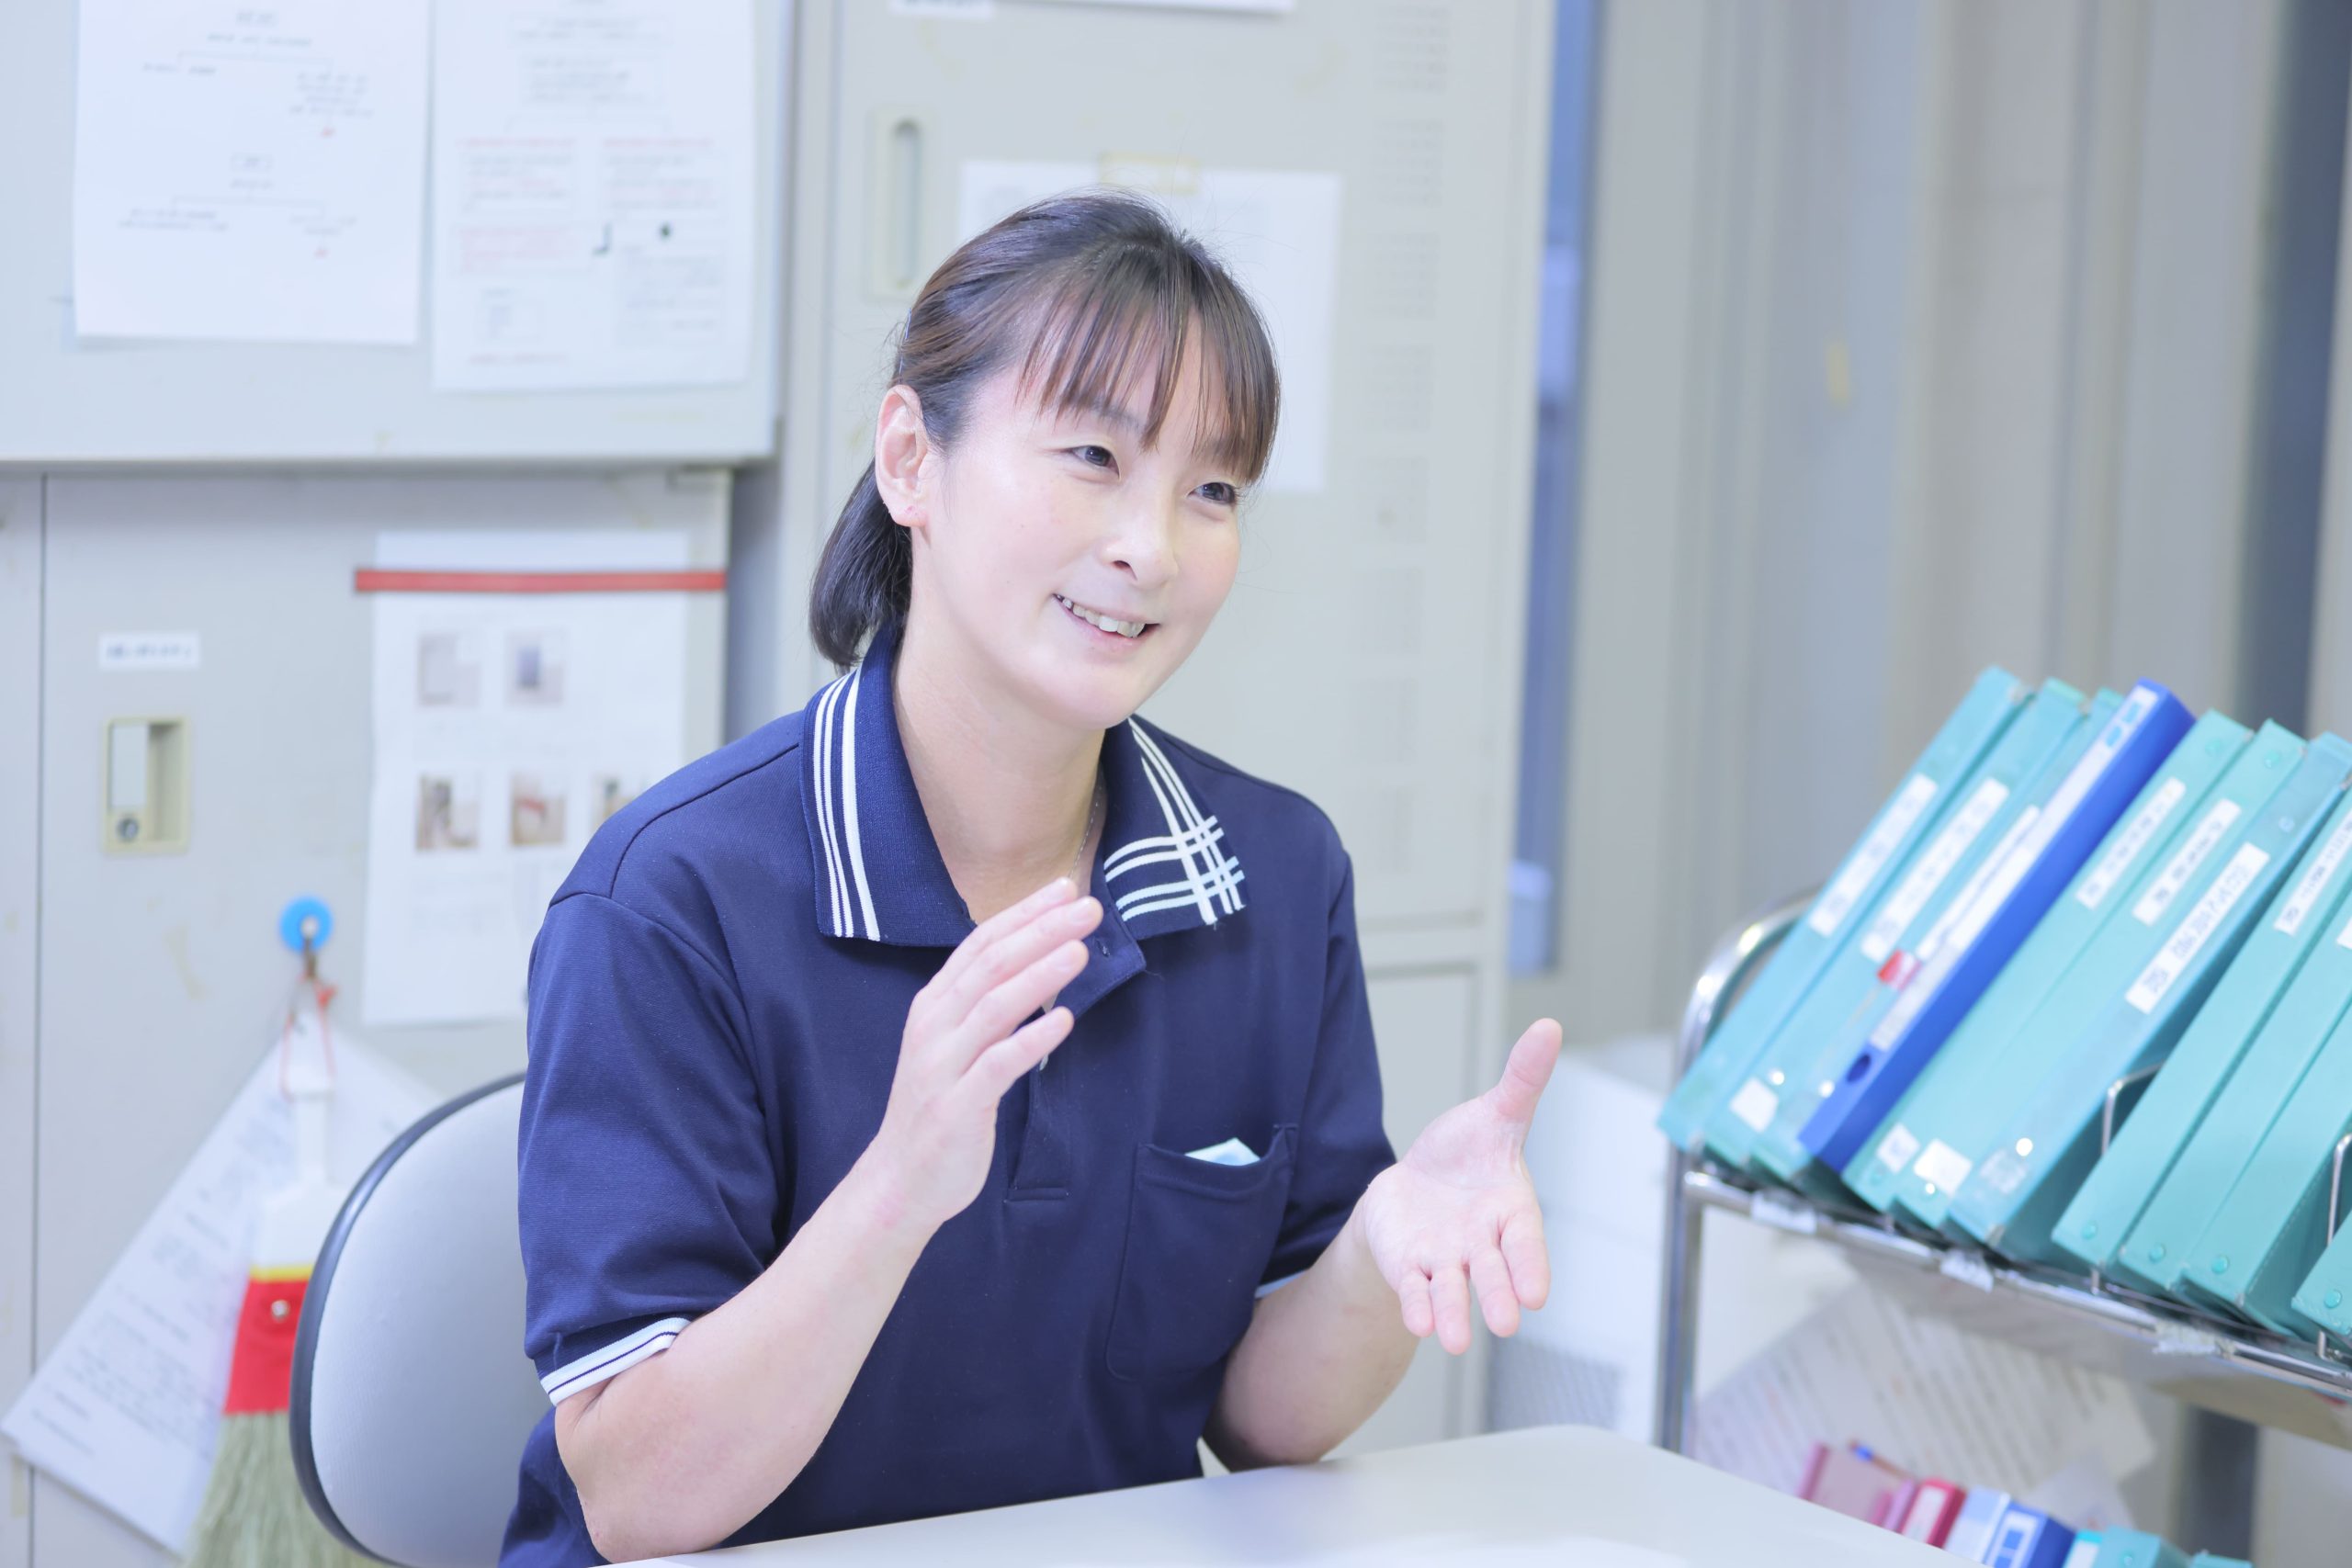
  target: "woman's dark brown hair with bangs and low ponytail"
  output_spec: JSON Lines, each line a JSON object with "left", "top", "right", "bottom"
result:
{"left": 809, "top": 188, "right": 1282, "bottom": 668}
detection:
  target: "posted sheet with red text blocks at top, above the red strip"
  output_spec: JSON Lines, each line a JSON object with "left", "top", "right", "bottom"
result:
{"left": 433, "top": 0, "right": 755, "bottom": 390}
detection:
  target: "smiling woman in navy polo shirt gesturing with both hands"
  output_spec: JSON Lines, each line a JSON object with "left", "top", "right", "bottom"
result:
{"left": 505, "top": 193, "right": 1559, "bottom": 1565}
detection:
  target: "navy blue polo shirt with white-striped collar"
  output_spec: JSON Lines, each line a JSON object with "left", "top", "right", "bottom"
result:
{"left": 501, "top": 620, "right": 1393, "bottom": 1568}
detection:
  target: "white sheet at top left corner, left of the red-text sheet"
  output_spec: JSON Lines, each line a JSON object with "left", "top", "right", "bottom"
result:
{"left": 72, "top": 0, "right": 430, "bottom": 344}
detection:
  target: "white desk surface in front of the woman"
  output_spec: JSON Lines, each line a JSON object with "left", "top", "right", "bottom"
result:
{"left": 635, "top": 1427, "right": 1954, "bottom": 1568}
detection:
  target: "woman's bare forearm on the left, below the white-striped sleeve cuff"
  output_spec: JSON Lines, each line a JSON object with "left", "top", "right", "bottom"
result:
{"left": 555, "top": 1159, "right": 932, "bottom": 1561}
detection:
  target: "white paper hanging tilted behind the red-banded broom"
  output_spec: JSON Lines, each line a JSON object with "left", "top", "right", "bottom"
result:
{"left": 0, "top": 1018, "right": 437, "bottom": 1551}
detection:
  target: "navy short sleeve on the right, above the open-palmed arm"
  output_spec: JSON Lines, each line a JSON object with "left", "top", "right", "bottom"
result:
{"left": 1261, "top": 851, "right": 1397, "bottom": 1288}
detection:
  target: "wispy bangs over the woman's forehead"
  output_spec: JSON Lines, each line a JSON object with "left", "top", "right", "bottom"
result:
{"left": 1021, "top": 247, "right": 1280, "bottom": 484}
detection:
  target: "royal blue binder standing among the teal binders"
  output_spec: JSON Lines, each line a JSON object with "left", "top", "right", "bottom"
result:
{"left": 1799, "top": 682, "right": 2189, "bottom": 1170}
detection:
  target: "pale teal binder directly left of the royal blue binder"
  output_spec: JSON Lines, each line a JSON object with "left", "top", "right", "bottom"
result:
{"left": 1743, "top": 686, "right": 2124, "bottom": 1197}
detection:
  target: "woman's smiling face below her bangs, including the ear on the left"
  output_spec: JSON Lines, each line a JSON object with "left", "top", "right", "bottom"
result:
{"left": 877, "top": 353, "right": 1239, "bottom": 728}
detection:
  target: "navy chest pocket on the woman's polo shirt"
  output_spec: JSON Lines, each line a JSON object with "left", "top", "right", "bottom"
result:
{"left": 1108, "top": 1126, "right": 1296, "bottom": 1382}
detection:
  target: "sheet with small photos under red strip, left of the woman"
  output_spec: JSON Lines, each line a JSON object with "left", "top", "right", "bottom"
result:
{"left": 362, "top": 531, "right": 687, "bottom": 1025}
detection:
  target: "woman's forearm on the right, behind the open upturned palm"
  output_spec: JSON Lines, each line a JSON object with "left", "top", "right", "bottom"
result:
{"left": 1206, "top": 1213, "right": 1419, "bottom": 1470}
